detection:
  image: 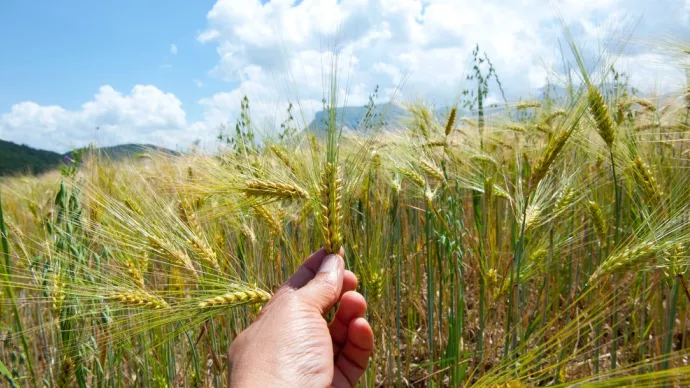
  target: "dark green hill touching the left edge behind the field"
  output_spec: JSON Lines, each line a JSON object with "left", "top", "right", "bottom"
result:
{"left": 0, "top": 140, "right": 63, "bottom": 175}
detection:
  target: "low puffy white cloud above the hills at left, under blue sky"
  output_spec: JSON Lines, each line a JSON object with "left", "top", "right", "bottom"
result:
{"left": 0, "top": 85, "right": 191, "bottom": 152}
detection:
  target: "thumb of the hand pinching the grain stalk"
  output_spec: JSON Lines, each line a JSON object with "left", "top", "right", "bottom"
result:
{"left": 297, "top": 254, "right": 345, "bottom": 314}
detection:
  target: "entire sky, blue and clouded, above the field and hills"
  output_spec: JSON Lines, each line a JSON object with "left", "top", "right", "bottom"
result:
{"left": 0, "top": 0, "right": 690, "bottom": 152}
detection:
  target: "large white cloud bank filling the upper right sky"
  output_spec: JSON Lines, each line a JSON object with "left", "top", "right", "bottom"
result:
{"left": 197, "top": 0, "right": 687, "bottom": 123}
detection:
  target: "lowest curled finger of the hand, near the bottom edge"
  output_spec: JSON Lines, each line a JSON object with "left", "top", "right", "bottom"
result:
{"left": 333, "top": 318, "right": 374, "bottom": 387}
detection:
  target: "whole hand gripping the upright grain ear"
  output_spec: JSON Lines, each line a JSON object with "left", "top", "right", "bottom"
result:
{"left": 228, "top": 248, "right": 374, "bottom": 388}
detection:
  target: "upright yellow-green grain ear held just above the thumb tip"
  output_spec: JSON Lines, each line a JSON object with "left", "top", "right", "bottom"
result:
{"left": 320, "top": 163, "right": 343, "bottom": 253}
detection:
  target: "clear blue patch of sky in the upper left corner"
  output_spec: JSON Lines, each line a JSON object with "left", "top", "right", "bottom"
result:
{"left": 0, "top": 0, "right": 218, "bottom": 117}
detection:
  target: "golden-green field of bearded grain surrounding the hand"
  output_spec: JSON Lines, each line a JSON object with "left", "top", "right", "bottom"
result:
{"left": 0, "top": 41, "right": 690, "bottom": 387}
